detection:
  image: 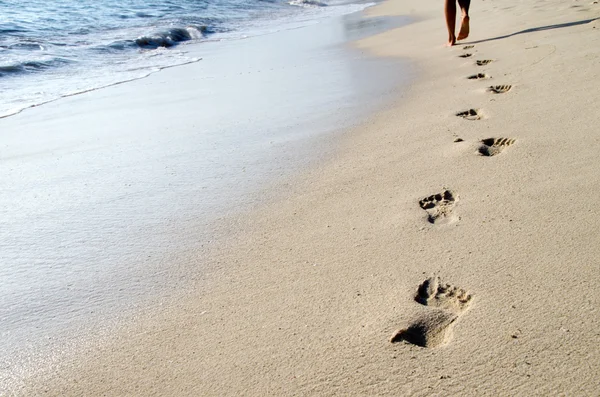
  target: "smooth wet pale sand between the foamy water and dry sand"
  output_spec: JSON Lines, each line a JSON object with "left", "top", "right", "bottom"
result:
{"left": 0, "top": 8, "right": 412, "bottom": 394}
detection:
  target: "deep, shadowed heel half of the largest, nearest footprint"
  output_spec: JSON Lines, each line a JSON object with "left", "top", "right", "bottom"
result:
{"left": 390, "top": 309, "right": 458, "bottom": 347}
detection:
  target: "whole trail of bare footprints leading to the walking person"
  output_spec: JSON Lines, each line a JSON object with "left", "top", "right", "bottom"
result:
{"left": 390, "top": 45, "right": 516, "bottom": 348}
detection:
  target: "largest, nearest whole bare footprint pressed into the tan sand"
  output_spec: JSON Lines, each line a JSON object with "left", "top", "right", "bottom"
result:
{"left": 390, "top": 277, "right": 473, "bottom": 347}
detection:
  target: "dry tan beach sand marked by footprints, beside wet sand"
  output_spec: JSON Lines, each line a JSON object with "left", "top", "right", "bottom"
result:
{"left": 5, "top": 0, "right": 600, "bottom": 396}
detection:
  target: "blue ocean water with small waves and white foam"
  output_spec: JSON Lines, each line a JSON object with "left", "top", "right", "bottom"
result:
{"left": 0, "top": 0, "right": 372, "bottom": 118}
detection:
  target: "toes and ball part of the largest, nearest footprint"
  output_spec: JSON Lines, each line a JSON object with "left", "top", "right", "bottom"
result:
{"left": 415, "top": 277, "right": 473, "bottom": 314}
